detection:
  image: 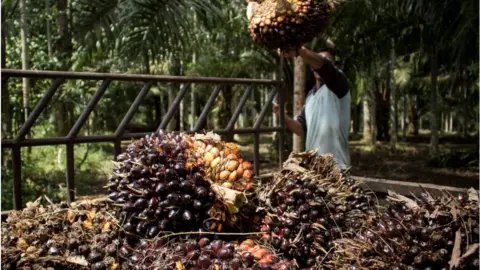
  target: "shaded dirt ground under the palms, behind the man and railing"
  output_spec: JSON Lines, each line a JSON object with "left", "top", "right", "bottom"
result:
{"left": 237, "top": 132, "right": 479, "bottom": 189}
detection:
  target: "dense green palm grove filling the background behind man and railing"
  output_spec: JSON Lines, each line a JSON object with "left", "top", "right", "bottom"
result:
{"left": 2, "top": 0, "right": 479, "bottom": 209}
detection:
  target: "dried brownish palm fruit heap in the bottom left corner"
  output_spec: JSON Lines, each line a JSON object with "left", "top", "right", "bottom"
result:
{"left": 1, "top": 198, "right": 119, "bottom": 270}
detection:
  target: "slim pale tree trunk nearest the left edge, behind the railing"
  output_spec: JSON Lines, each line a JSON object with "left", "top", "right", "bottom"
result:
{"left": 20, "top": 0, "right": 30, "bottom": 120}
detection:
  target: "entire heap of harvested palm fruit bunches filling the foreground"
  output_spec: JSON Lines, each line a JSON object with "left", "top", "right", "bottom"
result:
{"left": 1, "top": 131, "right": 479, "bottom": 270}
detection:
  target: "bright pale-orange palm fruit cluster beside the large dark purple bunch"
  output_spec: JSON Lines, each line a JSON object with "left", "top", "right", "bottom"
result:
{"left": 187, "top": 135, "right": 254, "bottom": 191}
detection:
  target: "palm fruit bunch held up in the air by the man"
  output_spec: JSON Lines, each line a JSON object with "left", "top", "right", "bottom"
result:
{"left": 248, "top": 0, "right": 330, "bottom": 49}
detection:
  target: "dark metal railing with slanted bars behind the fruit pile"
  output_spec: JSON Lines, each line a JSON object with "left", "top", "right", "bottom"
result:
{"left": 1, "top": 69, "right": 285, "bottom": 209}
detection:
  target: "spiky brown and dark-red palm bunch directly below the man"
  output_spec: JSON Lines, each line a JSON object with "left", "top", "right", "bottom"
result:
{"left": 261, "top": 152, "right": 375, "bottom": 269}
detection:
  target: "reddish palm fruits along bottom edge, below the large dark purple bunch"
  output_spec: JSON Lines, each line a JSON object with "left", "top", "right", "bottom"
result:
{"left": 121, "top": 237, "right": 295, "bottom": 270}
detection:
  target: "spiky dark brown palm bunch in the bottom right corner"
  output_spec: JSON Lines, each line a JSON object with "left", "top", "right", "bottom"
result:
{"left": 332, "top": 189, "right": 480, "bottom": 269}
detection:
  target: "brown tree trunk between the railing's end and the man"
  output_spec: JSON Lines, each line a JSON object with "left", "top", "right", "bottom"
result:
{"left": 293, "top": 57, "right": 306, "bottom": 152}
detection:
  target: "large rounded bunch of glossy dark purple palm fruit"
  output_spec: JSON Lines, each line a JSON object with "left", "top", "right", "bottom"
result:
{"left": 107, "top": 131, "right": 216, "bottom": 237}
